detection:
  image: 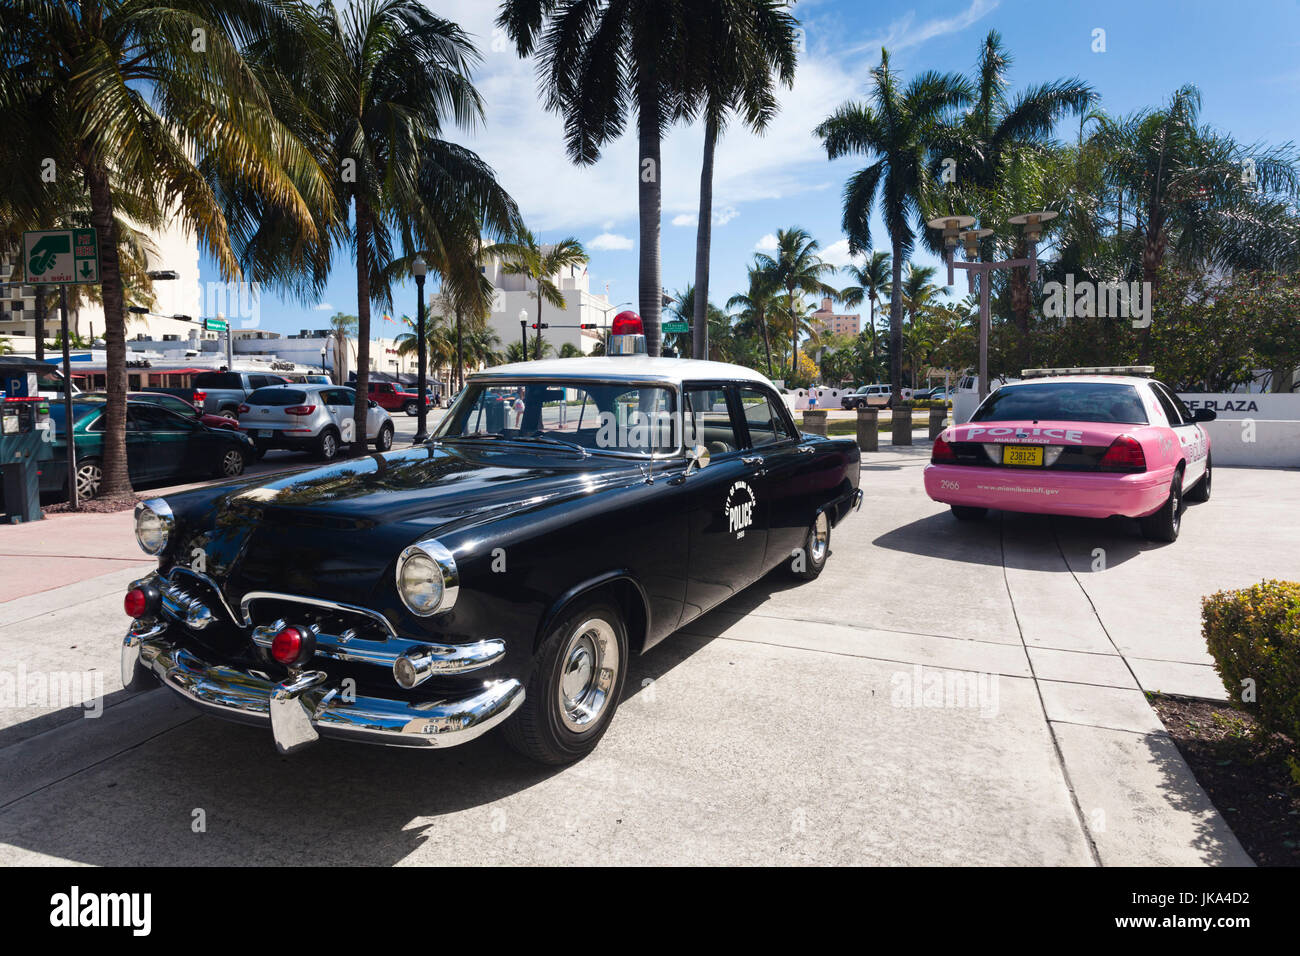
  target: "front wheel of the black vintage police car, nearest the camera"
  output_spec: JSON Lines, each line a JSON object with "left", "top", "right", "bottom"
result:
{"left": 504, "top": 598, "right": 628, "bottom": 765}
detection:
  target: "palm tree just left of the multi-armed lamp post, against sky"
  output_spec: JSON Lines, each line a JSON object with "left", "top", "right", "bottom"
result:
{"left": 816, "top": 49, "right": 971, "bottom": 418}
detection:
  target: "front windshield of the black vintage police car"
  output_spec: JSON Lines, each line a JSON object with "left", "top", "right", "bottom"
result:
{"left": 433, "top": 380, "right": 681, "bottom": 457}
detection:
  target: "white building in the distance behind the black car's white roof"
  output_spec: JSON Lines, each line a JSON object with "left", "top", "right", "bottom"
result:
{"left": 482, "top": 252, "right": 614, "bottom": 355}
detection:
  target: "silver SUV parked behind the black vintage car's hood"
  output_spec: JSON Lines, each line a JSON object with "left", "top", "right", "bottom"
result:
{"left": 239, "top": 385, "right": 393, "bottom": 462}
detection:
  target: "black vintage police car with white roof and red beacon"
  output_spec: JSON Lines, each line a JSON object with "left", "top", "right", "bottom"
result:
{"left": 122, "top": 317, "right": 861, "bottom": 763}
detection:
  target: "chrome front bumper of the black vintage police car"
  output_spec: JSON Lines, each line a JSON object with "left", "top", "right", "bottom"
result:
{"left": 122, "top": 624, "right": 524, "bottom": 753}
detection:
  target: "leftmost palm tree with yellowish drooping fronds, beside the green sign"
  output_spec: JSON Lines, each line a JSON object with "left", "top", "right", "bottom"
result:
{"left": 0, "top": 0, "right": 333, "bottom": 496}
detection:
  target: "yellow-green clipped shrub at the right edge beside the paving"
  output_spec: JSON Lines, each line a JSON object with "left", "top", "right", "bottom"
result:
{"left": 1201, "top": 581, "right": 1300, "bottom": 747}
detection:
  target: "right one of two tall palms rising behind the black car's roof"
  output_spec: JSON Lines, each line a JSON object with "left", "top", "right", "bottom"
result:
{"left": 686, "top": 0, "right": 798, "bottom": 359}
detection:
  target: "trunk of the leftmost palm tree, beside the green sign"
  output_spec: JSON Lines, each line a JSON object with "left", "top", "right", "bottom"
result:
{"left": 85, "top": 160, "right": 131, "bottom": 497}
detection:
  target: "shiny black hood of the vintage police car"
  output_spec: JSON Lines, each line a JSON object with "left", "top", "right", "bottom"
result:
{"left": 168, "top": 445, "right": 641, "bottom": 604}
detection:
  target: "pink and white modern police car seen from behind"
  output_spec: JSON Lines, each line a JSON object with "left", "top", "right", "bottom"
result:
{"left": 926, "top": 365, "right": 1214, "bottom": 541}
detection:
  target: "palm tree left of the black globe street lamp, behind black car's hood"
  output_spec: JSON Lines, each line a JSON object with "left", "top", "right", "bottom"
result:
{"left": 266, "top": 0, "right": 490, "bottom": 449}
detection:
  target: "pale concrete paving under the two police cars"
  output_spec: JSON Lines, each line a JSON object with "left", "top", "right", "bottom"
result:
{"left": 0, "top": 447, "right": 1284, "bottom": 865}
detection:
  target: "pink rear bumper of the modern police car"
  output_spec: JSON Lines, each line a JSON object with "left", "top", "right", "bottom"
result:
{"left": 926, "top": 464, "right": 1174, "bottom": 518}
